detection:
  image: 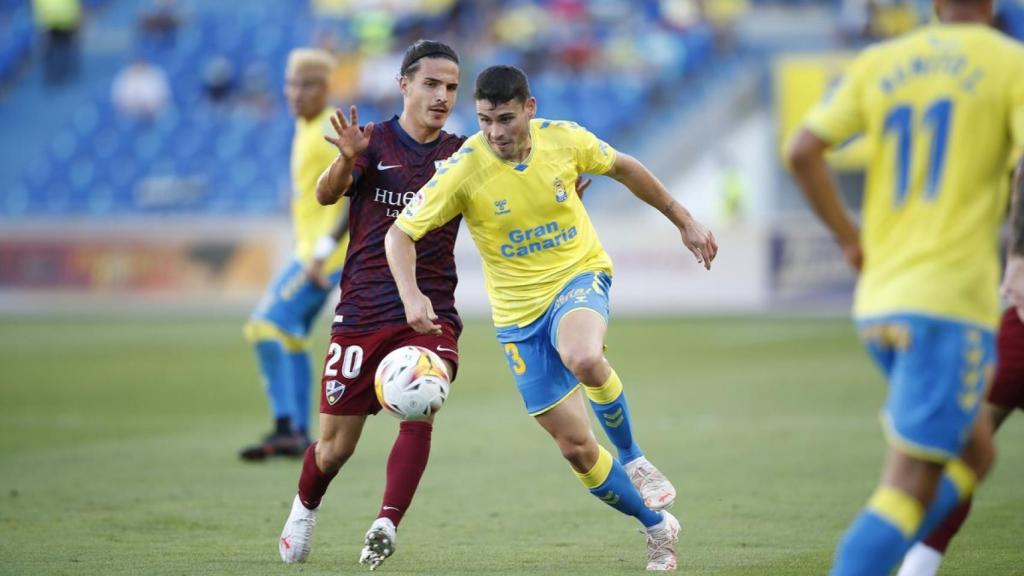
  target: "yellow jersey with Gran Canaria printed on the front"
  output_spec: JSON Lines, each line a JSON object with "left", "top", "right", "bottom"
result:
{"left": 396, "top": 119, "right": 615, "bottom": 327}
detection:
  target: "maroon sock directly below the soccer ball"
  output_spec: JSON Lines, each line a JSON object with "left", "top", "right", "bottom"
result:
{"left": 377, "top": 416, "right": 433, "bottom": 526}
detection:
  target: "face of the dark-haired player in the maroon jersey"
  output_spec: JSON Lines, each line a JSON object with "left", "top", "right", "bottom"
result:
{"left": 398, "top": 58, "right": 459, "bottom": 130}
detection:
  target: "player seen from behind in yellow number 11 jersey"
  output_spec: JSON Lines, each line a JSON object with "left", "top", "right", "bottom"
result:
{"left": 790, "top": 0, "right": 1024, "bottom": 576}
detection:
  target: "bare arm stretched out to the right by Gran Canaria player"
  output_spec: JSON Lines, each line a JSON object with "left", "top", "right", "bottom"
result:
{"left": 608, "top": 153, "right": 718, "bottom": 270}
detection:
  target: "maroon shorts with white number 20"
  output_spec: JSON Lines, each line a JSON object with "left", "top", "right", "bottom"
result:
{"left": 321, "top": 324, "right": 459, "bottom": 416}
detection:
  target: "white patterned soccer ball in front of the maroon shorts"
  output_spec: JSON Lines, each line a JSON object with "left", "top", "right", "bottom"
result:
{"left": 374, "top": 346, "right": 451, "bottom": 420}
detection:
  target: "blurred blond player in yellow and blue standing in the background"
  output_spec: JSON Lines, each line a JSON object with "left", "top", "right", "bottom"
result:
{"left": 241, "top": 48, "right": 348, "bottom": 460}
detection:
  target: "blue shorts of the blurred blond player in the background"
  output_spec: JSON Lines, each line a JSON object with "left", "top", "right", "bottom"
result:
{"left": 252, "top": 260, "right": 341, "bottom": 338}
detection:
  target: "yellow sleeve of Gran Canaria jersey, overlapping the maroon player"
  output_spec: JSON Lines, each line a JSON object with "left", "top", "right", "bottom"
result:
{"left": 395, "top": 153, "right": 471, "bottom": 242}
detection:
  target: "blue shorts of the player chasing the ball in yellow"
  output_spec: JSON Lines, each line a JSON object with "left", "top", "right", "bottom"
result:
{"left": 497, "top": 272, "right": 611, "bottom": 416}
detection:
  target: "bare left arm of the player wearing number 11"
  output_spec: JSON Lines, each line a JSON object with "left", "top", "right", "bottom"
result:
{"left": 786, "top": 128, "right": 863, "bottom": 272}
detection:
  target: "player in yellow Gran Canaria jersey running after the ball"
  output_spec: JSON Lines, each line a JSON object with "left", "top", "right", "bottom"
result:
{"left": 384, "top": 66, "right": 718, "bottom": 570}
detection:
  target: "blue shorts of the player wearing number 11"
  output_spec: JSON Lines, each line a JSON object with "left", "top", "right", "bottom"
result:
{"left": 857, "top": 314, "right": 995, "bottom": 462}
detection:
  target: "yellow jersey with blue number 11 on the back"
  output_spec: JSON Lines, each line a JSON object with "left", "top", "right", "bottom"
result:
{"left": 805, "top": 24, "right": 1024, "bottom": 327}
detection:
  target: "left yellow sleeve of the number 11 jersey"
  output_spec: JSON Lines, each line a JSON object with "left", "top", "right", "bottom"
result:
{"left": 804, "top": 50, "right": 872, "bottom": 145}
